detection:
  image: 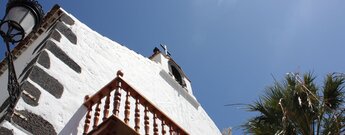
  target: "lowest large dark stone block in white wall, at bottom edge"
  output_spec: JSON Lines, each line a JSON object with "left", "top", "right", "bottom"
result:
{"left": 12, "top": 110, "right": 57, "bottom": 135}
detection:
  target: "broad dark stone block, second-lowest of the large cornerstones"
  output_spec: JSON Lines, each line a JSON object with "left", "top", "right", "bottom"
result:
{"left": 29, "top": 66, "right": 64, "bottom": 98}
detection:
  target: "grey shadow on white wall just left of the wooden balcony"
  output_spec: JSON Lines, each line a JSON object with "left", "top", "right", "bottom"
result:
{"left": 59, "top": 105, "right": 87, "bottom": 135}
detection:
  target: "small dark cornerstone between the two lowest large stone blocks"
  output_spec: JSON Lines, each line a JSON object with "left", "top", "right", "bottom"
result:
{"left": 21, "top": 81, "right": 41, "bottom": 106}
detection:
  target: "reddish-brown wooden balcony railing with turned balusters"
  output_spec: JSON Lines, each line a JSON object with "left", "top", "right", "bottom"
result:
{"left": 83, "top": 71, "right": 188, "bottom": 135}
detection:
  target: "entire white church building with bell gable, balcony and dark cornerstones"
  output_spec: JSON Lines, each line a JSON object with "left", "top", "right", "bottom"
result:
{"left": 0, "top": 5, "right": 221, "bottom": 135}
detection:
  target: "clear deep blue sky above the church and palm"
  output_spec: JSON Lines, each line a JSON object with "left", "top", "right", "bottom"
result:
{"left": 0, "top": 0, "right": 345, "bottom": 134}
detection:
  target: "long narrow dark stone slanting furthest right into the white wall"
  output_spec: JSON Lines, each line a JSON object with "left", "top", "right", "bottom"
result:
{"left": 45, "top": 40, "right": 81, "bottom": 73}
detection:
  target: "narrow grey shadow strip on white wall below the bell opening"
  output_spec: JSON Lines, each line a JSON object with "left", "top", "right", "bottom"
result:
{"left": 159, "top": 70, "right": 200, "bottom": 109}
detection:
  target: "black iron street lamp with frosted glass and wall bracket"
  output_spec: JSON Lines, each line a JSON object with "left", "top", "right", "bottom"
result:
{"left": 0, "top": 0, "right": 44, "bottom": 120}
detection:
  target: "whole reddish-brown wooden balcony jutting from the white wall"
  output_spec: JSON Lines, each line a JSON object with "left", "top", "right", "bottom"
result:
{"left": 83, "top": 71, "right": 188, "bottom": 135}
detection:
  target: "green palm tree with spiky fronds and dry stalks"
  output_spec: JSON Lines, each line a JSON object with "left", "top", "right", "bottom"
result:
{"left": 243, "top": 73, "right": 345, "bottom": 135}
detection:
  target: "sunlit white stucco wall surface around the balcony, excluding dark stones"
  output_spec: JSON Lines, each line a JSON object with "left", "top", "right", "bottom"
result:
{"left": 0, "top": 7, "right": 221, "bottom": 135}
